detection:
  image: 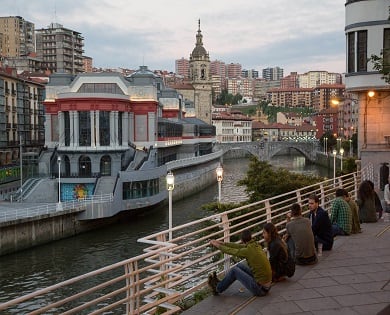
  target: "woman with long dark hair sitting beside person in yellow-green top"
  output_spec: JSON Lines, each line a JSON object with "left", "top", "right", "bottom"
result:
{"left": 263, "top": 223, "right": 288, "bottom": 282}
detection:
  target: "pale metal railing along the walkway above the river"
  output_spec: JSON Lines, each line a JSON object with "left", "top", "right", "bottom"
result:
{"left": 0, "top": 171, "right": 362, "bottom": 314}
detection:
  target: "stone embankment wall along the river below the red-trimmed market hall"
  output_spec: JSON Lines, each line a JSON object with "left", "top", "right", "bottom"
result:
{"left": 0, "top": 159, "right": 219, "bottom": 256}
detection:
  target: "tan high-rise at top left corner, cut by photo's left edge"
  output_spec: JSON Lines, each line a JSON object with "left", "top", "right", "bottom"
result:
{"left": 0, "top": 16, "right": 35, "bottom": 57}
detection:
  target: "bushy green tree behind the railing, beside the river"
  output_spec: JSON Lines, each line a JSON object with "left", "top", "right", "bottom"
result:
{"left": 238, "top": 157, "right": 322, "bottom": 202}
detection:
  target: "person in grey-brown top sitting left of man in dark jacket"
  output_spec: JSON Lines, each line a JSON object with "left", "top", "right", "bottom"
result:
{"left": 284, "top": 203, "right": 318, "bottom": 265}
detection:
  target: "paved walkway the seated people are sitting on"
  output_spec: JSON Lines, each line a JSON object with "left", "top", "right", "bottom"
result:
{"left": 182, "top": 220, "right": 390, "bottom": 315}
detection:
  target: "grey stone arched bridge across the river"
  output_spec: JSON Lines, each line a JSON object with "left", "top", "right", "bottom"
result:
{"left": 215, "top": 141, "right": 319, "bottom": 162}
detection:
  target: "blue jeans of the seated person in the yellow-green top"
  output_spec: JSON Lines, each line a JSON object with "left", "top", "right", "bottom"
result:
{"left": 217, "top": 263, "right": 269, "bottom": 296}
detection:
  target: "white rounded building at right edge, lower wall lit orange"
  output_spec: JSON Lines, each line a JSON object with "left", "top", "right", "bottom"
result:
{"left": 345, "top": 0, "right": 390, "bottom": 176}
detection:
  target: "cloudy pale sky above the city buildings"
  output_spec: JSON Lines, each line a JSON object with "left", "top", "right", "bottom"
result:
{"left": 0, "top": 0, "right": 345, "bottom": 75}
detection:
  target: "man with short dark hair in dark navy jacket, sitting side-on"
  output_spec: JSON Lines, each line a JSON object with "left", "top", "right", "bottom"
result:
{"left": 308, "top": 194, "right": 333, "bottom": 250}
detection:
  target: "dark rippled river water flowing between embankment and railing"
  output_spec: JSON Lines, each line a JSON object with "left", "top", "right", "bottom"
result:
{"left": 0, "top": 155, "right": 327, "bottom": 308}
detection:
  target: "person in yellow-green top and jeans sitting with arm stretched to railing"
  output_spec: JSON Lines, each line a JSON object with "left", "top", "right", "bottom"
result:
{"left": 208, "top": 230, "right": 272, "bottom": 296}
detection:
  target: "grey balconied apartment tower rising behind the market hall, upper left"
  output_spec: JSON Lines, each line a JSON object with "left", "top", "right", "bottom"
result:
{"left": 36, "top": 23, "right": 84, "bottom": 74}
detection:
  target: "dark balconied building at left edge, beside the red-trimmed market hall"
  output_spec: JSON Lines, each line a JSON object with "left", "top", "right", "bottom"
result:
{"left": 0, "top": 68, "right": 45, "bottom": 168}
